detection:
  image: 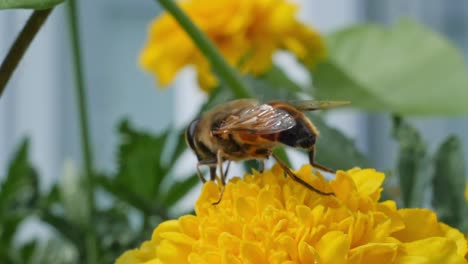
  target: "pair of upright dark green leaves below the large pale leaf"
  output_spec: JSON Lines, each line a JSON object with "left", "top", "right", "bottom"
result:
{"left": 393, "top": 116, "right": 468, "bottom": 229}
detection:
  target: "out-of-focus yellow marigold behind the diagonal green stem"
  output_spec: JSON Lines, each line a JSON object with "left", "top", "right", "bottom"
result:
{"left": 140, "top": 0, "right": 325, "bottom": 91}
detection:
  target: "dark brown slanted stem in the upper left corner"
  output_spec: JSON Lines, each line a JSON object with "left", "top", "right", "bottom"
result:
{"left": 0, "top": 8, "right": 53, "bottom": 98}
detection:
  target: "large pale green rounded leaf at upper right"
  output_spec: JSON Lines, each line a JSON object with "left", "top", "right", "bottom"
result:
{"left": 313, "top": 20, "right": 468, "bottom": 115}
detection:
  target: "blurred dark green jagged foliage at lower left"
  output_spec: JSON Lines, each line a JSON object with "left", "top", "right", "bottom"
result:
{"left": 0, "top": 120, "right": 199, "bottom": 263}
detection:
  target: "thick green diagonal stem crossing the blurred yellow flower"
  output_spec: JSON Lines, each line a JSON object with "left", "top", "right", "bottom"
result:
{"left": 158, "top": 0, "right": 252, "bottom": 98}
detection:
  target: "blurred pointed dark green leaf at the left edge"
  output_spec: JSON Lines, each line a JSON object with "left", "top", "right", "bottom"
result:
{"left": 0, "top": 140, "right": 39, "bottom": 221}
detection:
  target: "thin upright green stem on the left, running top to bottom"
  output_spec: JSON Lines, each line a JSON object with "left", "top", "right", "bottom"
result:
{"left": 67, "top": 0, "right": 99, "bottom": 264}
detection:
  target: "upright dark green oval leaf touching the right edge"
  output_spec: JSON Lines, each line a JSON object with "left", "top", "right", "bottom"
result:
{"left": 432, "top": 136, "right": 466, "bottom": 227}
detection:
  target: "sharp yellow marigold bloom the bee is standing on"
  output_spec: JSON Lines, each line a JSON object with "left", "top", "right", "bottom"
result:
{"left": 116, "top": 165, "right": 467, "bottom": 264}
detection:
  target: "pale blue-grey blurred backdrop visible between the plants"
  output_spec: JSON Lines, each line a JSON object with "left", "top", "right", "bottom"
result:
{"left": 0, "top": 0, "right": 468, "bottom": 260}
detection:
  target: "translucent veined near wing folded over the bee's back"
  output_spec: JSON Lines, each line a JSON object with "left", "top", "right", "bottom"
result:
{"left": 212, "top": 104, "right": 296, "bottom": 135}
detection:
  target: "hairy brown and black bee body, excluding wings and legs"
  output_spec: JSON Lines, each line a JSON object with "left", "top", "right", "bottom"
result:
{"left": 187, "top": 99, "right": 318, "bottom": 161}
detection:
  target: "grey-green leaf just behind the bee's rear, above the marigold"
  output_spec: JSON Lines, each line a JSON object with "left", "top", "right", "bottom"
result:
{"left": 309, "top": 115, "right": 369, "bottom": 170}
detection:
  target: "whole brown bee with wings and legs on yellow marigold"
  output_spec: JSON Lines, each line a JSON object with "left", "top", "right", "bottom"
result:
{"left": 185, "top": 99, "right": 349, "bottom": 204}
